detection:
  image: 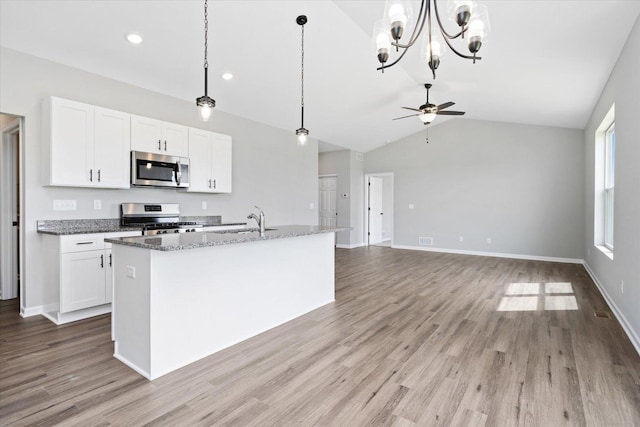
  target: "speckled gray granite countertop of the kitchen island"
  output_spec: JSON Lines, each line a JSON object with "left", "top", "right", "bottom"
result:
{"left": 104, "top": 225, "right": 350, "bottom": 251}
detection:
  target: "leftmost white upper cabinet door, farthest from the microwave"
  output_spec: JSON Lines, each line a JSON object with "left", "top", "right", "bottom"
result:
{"left": 49, "top": 98, "right": 95, "bottom": 187}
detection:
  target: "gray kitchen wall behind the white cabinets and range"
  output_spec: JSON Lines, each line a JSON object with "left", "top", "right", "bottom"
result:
{"left": 0, "top": 48, "right": 318, "bottom": 308}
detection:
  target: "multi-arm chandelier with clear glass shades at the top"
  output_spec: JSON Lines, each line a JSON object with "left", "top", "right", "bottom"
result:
{"left": 373, "top": 0, "right": 491, "bottom": 79}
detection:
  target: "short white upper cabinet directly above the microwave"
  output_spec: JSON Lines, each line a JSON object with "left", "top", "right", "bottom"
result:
{"left": 131, "top": 115, "right": 189, "bottom": 157}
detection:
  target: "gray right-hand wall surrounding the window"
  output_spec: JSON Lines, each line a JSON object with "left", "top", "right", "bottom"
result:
{"left": 584, "top": 19, "right": 640, "bottom": 351}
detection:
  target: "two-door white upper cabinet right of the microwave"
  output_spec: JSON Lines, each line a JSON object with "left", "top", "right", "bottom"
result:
{"left": 187, "top": 128, "right": 232, "bottom": 193}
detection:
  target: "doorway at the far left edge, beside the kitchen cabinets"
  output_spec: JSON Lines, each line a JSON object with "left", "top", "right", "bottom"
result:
{"left": 0, "top": 114, "right": 23, "bottom": 300}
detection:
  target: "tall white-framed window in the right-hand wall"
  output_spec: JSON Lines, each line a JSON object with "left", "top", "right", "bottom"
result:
{"left": 593, "top": 106, "right": 616, "bottom": 259}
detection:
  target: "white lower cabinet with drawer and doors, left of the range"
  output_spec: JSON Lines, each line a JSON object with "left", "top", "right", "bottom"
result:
{"left": 44, "top": 231, "right": 141, "bottom": 324}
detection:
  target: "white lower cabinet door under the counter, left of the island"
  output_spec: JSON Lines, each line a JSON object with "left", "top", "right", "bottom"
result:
{"left": 60, "top": 250, "right": 108, "bottom": 313}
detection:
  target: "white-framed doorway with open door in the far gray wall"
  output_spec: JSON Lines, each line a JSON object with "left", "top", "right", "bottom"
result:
{"left": 364, "top": 173, "right": 393, "bottom": 246}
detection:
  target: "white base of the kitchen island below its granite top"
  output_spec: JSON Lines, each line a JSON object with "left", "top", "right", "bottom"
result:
{"left": 112, "top": 233, "right": 335, "bottom": 380}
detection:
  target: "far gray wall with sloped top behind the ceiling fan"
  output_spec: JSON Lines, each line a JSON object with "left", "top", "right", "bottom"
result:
{"left": 365, "top": 119, "right": 584, "bottom": 259}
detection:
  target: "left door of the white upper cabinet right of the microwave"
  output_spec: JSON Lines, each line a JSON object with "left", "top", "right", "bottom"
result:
{"left": 188, "top": 128, "right": 212, "bottom": 193}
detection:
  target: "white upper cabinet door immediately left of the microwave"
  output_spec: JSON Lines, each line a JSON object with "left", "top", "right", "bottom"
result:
{"left": 93, "top": 107, "right": 131, "bottom": 188}
